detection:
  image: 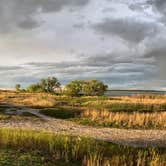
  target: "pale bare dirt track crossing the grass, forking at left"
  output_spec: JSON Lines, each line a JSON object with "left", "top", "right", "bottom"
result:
{"left": 0, "top": 107, "right": 166, "bottom": 147}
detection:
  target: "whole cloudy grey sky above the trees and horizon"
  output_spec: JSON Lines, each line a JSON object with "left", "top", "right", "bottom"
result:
{"left": 0, "top": 0, "right": 166, "bottom": 90}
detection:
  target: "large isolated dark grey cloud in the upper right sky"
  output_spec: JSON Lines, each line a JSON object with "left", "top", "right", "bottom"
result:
{"left": 93, "top": 18, "right": 158, "bottom": 43}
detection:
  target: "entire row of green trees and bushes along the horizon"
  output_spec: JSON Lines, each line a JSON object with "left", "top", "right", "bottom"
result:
{"left": 15, "top": 77, "right": 108, "bottom": 96}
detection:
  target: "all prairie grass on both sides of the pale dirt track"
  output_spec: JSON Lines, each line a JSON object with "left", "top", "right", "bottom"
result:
{"left": 0, "top": 91, "right": 166, "bottom": 166}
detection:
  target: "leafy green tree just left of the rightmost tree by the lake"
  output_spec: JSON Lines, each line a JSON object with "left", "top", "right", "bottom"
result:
{"left": 66, "top": 80, "right": 84, "bottom": 96}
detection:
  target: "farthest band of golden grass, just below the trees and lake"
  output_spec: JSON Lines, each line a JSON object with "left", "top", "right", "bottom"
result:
{"left": 0, "top": 91, "right": 166, "bottom": 108}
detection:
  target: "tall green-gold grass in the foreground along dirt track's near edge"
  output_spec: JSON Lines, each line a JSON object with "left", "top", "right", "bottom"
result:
{"left": 0, "top": 129, "right": 166, "bottom": 166}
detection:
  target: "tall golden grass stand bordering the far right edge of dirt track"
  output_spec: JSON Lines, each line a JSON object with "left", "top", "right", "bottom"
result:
{"left": 81, "top": 110, "right": 166, "bottom": 128}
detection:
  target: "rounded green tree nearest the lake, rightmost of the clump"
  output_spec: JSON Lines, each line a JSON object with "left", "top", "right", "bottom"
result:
{"left": 82, "top": 80, "right": 108, "bottom": 96}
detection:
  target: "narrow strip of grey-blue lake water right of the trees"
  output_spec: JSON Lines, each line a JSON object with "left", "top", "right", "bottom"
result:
{"left": 105, "top": 90, "right": 166, "bottom": 96}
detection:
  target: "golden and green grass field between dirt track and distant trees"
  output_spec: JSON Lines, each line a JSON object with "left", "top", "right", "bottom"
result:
{"left": 0, "top": 91, "right": 166, "bottom": 129}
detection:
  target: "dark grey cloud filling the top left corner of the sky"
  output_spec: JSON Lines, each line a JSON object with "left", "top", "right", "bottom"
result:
{"left": 0, "top": 0, "right": 90, "bottom": 33}
